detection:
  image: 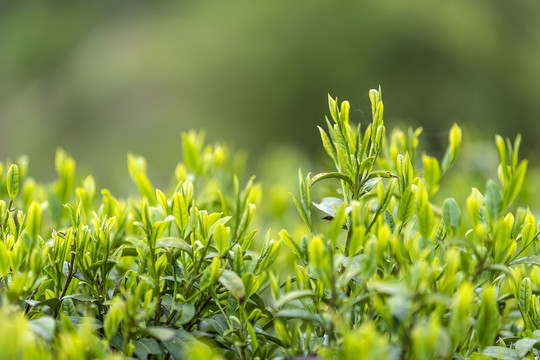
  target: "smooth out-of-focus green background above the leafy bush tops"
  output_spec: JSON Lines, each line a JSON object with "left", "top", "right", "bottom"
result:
{"left": 0, "top": 0, "right": 540, "bottom": 188}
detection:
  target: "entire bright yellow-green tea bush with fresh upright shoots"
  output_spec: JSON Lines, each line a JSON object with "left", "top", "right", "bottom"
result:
{"left": 0, "top": 89, "right": 540, "bottom": 359}
